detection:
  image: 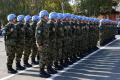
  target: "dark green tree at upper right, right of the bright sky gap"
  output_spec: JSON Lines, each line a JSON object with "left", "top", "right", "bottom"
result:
{"left": 74, "top": 0, "right": 112, "bottom": 16}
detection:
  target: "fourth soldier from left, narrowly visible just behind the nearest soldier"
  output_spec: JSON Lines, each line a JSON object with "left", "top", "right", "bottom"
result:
{"left": 31, "top": 15, "right": 39, "bottom": 65}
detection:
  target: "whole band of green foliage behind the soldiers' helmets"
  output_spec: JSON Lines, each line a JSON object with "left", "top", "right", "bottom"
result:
{"left": 0, "top": 0, "right": 120, "bottom": 23}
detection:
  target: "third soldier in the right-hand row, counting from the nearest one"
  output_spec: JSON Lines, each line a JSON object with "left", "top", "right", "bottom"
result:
{"left": 56, "top": 13, "right": 67, "bottom": 69}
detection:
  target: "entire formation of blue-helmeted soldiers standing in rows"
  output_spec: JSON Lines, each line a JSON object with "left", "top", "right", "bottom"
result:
{"left": 4, "top": 10, "right": 117, "bottom": 78}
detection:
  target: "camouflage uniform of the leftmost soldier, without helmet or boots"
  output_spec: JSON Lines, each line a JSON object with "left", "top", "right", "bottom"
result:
{"left": 4, "top": 23, "right": 17, "bottom": 68}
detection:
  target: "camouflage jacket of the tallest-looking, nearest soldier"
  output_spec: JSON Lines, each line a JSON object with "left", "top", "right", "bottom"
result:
{"left": 35, "top": 19, "right": 49, "bottom": 46}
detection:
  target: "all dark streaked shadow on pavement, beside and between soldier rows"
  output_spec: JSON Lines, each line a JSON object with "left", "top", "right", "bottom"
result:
{"left": 12, "top": 40, "right": 120, "bottom": 80}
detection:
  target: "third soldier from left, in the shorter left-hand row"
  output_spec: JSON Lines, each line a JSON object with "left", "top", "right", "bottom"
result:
{"left": 23, "top": 15, "right": 34, "bottom": 67}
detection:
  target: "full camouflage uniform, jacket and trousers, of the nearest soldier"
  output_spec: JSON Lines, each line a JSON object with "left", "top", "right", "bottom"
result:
{"left": 36, "top": 18, "right": 49, "bottom": 70}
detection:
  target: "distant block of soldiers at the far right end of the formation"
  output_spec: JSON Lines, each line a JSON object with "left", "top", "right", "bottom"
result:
{"left": 99, "top": 19, "right": 117, "bottom": 46}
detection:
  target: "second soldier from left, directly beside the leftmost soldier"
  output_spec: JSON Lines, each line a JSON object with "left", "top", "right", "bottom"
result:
{"left": 16, "top": 15, "right": 25, "bottom": 70}
